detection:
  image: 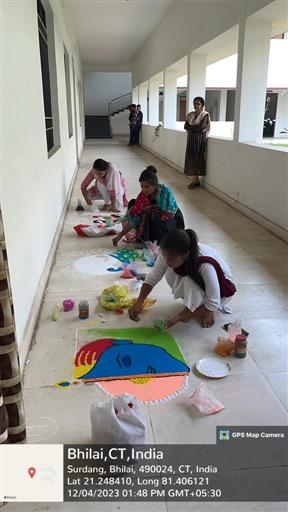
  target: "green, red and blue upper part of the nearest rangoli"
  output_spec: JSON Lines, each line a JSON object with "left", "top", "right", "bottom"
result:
{"left": 74, "top": 327, "right": 190, "bottom": 380}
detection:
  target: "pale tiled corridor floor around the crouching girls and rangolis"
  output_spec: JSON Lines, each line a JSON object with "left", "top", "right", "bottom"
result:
{"left": 4, "top": 140, "right": 288, "bottom": 512}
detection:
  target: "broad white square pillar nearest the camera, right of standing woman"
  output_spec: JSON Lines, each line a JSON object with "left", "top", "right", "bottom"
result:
{"left": 234, "top": 19, "right": 271, "bottom": 142}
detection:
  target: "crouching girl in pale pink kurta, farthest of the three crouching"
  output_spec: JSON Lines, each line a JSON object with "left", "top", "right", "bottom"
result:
{"left": 81, "top": 158, "right": 128, "bottom": 212}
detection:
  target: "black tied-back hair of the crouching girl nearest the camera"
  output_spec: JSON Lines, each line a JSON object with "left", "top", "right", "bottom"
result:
{"left": 160, "top": 229, "right": 205, "bottom": 291}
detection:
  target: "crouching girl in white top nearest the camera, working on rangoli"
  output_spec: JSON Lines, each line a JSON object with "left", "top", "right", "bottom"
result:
{"left": 129, "top": 229, "right": 236, "bottom": 328}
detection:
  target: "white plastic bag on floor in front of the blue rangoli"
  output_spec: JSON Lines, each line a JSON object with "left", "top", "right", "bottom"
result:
{"left": 90, "top": 393, "right": 146, "bottom": 445}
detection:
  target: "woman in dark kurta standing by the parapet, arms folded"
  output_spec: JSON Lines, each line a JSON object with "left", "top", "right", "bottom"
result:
{"left": 184, "top": 96, "right": 210, "bottom": 189}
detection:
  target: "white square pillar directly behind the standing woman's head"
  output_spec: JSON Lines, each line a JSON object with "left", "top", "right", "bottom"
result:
{"left": 187, "top": 53, "right": 207, "bottom": 112}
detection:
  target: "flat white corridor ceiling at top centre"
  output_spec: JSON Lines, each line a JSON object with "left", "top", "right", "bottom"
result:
{"left": 62, "top": 0, "right": 173, "bottom": 71}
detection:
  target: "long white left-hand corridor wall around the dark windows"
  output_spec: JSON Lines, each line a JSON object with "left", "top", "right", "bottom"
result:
{"left": 1, "top": 0, "right": 83, "bottom": 358}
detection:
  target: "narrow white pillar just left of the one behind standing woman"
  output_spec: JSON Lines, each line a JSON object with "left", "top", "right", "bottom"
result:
{"left": 164, "top": 69, "right": 178, "bottom": 129}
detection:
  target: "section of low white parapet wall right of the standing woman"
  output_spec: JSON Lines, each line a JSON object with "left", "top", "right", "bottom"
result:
{"left": 206, "top": 138, "right": 288, "bottom": 234}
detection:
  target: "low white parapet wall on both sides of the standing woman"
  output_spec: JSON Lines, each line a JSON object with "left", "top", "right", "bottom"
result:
{"left": 142, "top": 125, "right": 288, "bottom": 238}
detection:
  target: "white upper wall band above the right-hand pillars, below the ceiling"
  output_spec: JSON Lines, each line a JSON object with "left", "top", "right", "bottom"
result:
{"left": 132, "top": 0, "right": 271, "bottom": 87}
